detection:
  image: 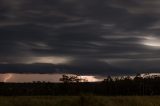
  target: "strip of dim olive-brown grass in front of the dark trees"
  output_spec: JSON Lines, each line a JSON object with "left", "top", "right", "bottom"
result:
{"left": 0, "top": 96, "right": 160, "bottom": 106}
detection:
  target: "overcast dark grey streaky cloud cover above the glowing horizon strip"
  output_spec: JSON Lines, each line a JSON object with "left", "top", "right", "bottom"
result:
{"left": 0, "top": 0, "right": 160, "bottom": 80}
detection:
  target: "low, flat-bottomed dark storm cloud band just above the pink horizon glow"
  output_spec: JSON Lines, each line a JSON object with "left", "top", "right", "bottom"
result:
{"left": 0, "top": 60, "right": 125, "bottom": 76}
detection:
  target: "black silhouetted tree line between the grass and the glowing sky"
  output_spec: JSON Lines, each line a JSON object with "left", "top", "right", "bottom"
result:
{"left": 0, "top": 75, "right": 160, "bottom": 96}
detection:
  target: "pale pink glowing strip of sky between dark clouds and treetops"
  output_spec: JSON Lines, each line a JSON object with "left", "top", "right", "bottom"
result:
{"left": 0, "top": 73, "right": 160, "bottom": 83}
